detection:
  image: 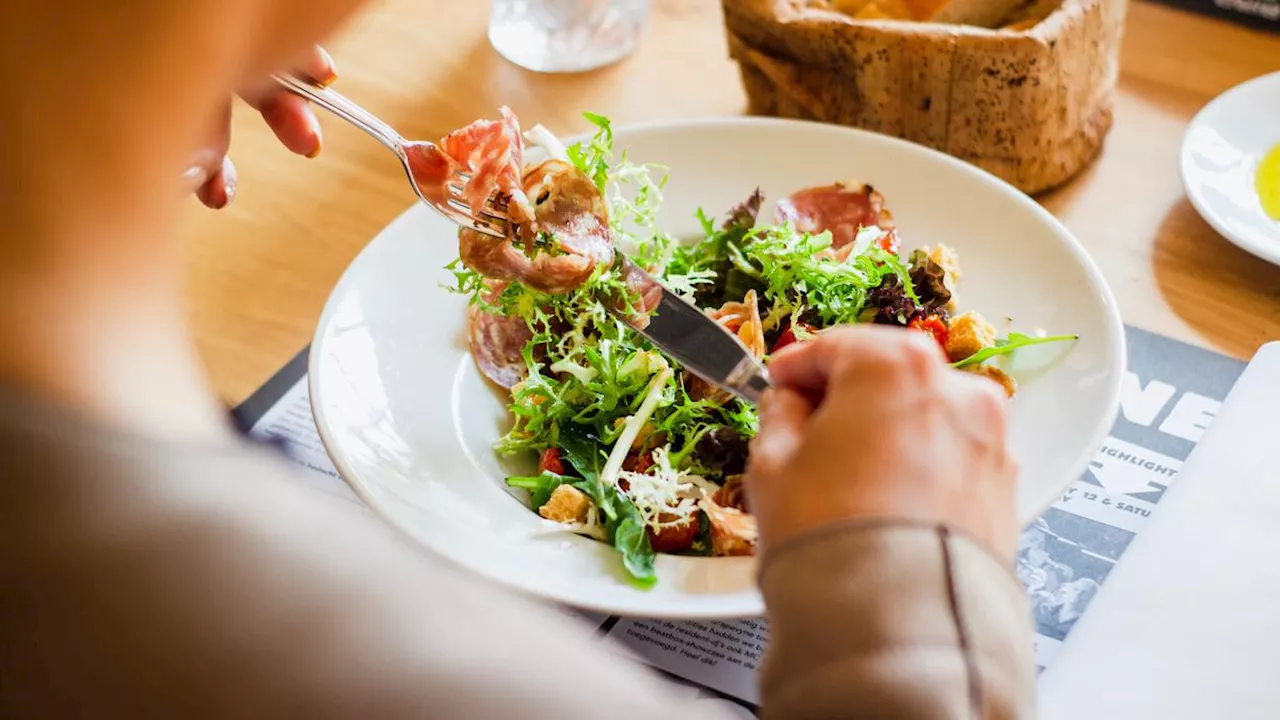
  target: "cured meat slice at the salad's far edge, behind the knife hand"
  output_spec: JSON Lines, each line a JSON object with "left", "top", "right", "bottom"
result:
{"left": 774, "top": 181, "right": 893, "bottom": 249}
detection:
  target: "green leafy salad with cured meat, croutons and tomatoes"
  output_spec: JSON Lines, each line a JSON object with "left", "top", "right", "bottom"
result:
{"left": 419, "top": 109, "right": 1073, "bottom": 587}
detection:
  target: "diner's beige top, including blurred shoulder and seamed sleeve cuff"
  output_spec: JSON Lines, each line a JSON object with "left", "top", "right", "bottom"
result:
{"left": 0, "top": 393, "right": 1032, "bottom": 720}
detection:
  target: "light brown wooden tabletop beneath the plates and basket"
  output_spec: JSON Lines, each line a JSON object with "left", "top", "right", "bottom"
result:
{"left": 183, "top": 0, "right": 1280, "bottom": 402}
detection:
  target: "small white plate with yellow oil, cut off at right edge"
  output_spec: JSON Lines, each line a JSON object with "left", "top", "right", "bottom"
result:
{"left": 1179, "top": 73, "right": 1280, "bottom": 265}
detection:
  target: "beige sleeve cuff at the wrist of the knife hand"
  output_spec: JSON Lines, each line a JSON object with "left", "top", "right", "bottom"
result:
{"left": 760, "top": 523, "right": 1034, "bottom": 720}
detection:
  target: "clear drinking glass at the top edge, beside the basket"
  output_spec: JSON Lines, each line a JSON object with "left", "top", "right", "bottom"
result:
{"left": 489, "top": 0, "right": 649, "bottom": 73}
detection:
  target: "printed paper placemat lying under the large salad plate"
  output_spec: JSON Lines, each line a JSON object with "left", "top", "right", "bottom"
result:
{"left": 236, "top": 328, "right": 1244, "bottom": 717}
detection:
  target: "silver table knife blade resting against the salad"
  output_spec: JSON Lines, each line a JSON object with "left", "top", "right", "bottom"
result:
{"left": 605, "top": 252, "right": 769, "bottom": 405}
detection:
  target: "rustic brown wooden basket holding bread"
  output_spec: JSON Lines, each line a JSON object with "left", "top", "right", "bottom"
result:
{"left": 723, "top": 0, "right": 1128, "bottom": 192}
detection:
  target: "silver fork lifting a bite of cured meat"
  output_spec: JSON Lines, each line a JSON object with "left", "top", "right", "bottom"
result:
{"left": 273, "top": 74, "right": 507, "bottom": 237}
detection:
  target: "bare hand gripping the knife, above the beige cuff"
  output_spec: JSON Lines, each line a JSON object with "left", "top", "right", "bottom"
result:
{"left": 748, "top": 327, "right": 1018, "bottom": 561}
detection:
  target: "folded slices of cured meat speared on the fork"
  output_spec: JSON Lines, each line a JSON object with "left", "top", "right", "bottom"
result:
{"left": 411, "top": 108, "right": 613, "bottom": 293}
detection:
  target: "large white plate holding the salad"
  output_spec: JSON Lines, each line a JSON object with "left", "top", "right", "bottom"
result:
{"left": 310, "top": 119, "right": 1124, "bottom": 618}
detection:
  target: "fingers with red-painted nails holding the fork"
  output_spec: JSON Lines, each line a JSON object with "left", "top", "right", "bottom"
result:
{"left": 183, "top": 46, "right": 338, "bottom": 210}
